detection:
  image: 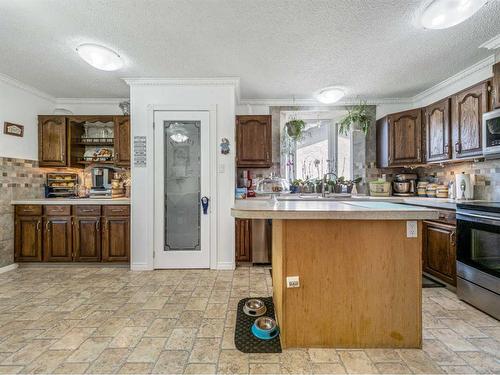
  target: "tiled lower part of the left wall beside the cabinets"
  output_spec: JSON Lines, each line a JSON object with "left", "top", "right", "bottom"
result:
{"left": 0, "top": 157, "right": 45, "bottom": 267}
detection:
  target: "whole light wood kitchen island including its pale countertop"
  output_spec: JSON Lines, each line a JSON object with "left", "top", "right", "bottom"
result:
{"left": 232, "top": 199, "right": 438, "bottom": 348}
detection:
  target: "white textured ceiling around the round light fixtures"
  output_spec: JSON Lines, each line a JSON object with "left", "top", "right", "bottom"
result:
{"left": 0, "top": 0, "right": 500, "bottom": 99}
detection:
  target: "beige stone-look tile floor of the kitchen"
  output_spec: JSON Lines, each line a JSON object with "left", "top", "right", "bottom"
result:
{"left": 0, "top": 268, "right": 500, "bottom": 374}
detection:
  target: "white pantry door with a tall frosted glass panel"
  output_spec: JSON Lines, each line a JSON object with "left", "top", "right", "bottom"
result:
{"left": 154, "top": 111, "right": 211, "bottom": 268}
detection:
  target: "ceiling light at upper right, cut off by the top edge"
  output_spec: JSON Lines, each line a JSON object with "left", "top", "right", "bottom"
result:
{"left": 420, "top": 0, "right": 488, "bottom": 29}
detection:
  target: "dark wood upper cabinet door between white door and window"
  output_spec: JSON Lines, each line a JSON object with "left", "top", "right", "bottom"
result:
{"left": 236, "top": 115, "right": 273, "bottom": 168}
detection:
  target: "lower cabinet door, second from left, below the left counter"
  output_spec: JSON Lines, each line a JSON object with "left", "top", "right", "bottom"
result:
{"left": 43, "top": 216, "right": 73, "bottom": 262}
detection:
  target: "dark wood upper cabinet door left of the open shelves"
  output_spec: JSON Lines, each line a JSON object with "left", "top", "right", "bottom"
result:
{"left": 38, "top": 116, "right": 68, "bottom": 167}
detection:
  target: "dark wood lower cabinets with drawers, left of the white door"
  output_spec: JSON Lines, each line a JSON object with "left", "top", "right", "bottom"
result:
{"left": 14, "top": 205, "right": 130, "bottom": 262}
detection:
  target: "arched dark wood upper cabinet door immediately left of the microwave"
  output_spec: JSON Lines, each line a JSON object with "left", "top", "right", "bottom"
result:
{"left": 452, "top": 82, "right": 488, "bottom": 158}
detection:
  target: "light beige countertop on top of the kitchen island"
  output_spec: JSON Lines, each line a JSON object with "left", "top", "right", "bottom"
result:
{"left": 231, "top": 199, "right": 438, "bottom": 220}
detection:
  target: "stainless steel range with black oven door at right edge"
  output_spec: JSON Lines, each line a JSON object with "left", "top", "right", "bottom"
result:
{"left": 457, "top": 202, "right": 500, "bottom": 319}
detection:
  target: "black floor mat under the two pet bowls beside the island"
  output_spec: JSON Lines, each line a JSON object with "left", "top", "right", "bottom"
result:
{"left": 234, "top": 297, "right": 281, "bottom": 353}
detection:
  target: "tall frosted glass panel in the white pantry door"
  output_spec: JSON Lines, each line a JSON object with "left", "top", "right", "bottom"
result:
{"left": 164, "top": 121, "right": 201, "bottom": 251}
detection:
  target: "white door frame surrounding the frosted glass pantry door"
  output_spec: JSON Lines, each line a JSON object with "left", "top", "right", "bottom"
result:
{"left": 148, "top": 105, "right": 219, "bottom": 269}
